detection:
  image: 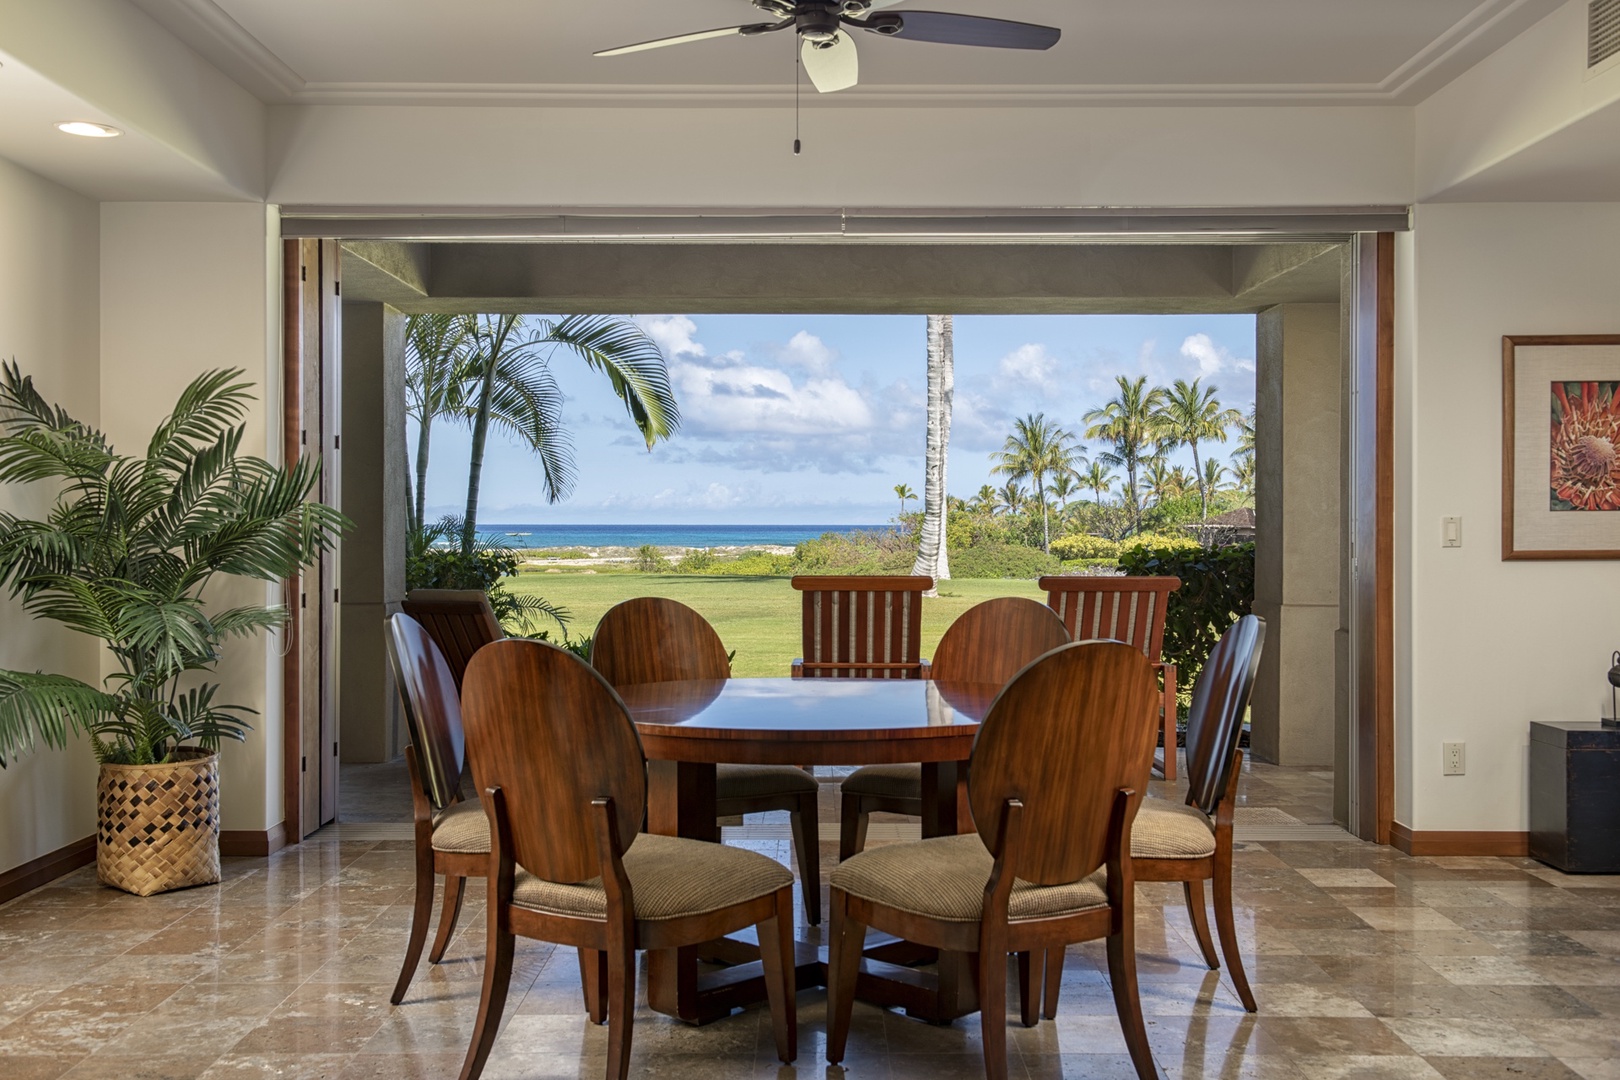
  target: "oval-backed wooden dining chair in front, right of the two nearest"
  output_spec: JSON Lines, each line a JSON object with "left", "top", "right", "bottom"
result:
{"left": 826, "top": 641, "right": 1158, "bottom": 1080}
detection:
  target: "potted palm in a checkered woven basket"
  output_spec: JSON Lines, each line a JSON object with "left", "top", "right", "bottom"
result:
{"left": 0, "top": 363, "right": 345, "bottom": 895}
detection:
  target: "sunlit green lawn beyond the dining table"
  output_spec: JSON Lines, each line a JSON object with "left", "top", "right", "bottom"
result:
{"left": 512, "top": 572, "right": 1047, "bottom": 678}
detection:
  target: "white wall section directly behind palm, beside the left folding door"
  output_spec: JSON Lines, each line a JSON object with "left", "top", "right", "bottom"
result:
{"left": 100, "top": 202, "right": 282, "bottom": 831}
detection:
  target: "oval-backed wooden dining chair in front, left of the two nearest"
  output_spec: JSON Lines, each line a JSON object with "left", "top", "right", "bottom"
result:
{"left": 460, "top": 640, "right": 799, "bottom": 1080}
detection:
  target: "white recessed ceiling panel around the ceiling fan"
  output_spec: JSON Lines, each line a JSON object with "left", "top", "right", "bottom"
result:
{"left": 133, "top": 0, "right": 1560, "bottom": 105}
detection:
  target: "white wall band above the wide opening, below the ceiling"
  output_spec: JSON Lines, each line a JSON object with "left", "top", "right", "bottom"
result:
{"left": 269, "top": 105, "right": 1413, "bottom": 207}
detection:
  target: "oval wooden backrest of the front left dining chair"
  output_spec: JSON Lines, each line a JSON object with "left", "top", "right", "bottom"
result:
{"left": 462, "top": 638, "right": 646, "bottom": 882}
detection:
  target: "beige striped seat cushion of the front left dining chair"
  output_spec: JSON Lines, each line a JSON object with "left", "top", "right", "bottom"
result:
{"left": 512, "top": 832, "right": 794, "bottom": 920}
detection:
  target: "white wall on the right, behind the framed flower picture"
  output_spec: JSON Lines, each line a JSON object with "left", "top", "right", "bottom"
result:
{"left": 1395, "top": 202, "right": 1620, "bottom": 831}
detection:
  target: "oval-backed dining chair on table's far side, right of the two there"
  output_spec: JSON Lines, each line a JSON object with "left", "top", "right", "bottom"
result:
{"left": 838, "top": 596, "right": 1069, "bottom": 860}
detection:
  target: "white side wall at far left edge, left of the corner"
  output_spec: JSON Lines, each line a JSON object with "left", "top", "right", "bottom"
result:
{"left": 0, "top": 159, "right": 100, "bottom": 871}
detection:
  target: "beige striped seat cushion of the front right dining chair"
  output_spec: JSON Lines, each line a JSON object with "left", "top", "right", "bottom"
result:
{"left": 831, "top": 832, "right": 1108, "bottom": 923}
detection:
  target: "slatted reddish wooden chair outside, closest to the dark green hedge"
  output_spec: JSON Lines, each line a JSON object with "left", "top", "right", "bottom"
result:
{"left": 1040, "top": 573, "right": 1181, "bottom": 780}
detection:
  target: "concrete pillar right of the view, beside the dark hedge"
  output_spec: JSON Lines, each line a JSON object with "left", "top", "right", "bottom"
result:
{"left": 1251, "top": 304, "right": 1343, "bottom": 766}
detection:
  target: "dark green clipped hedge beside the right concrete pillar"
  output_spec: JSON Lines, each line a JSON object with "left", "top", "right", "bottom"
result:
{"left": 1119, "top": 538, "right": 1254, "bottom": 701}
